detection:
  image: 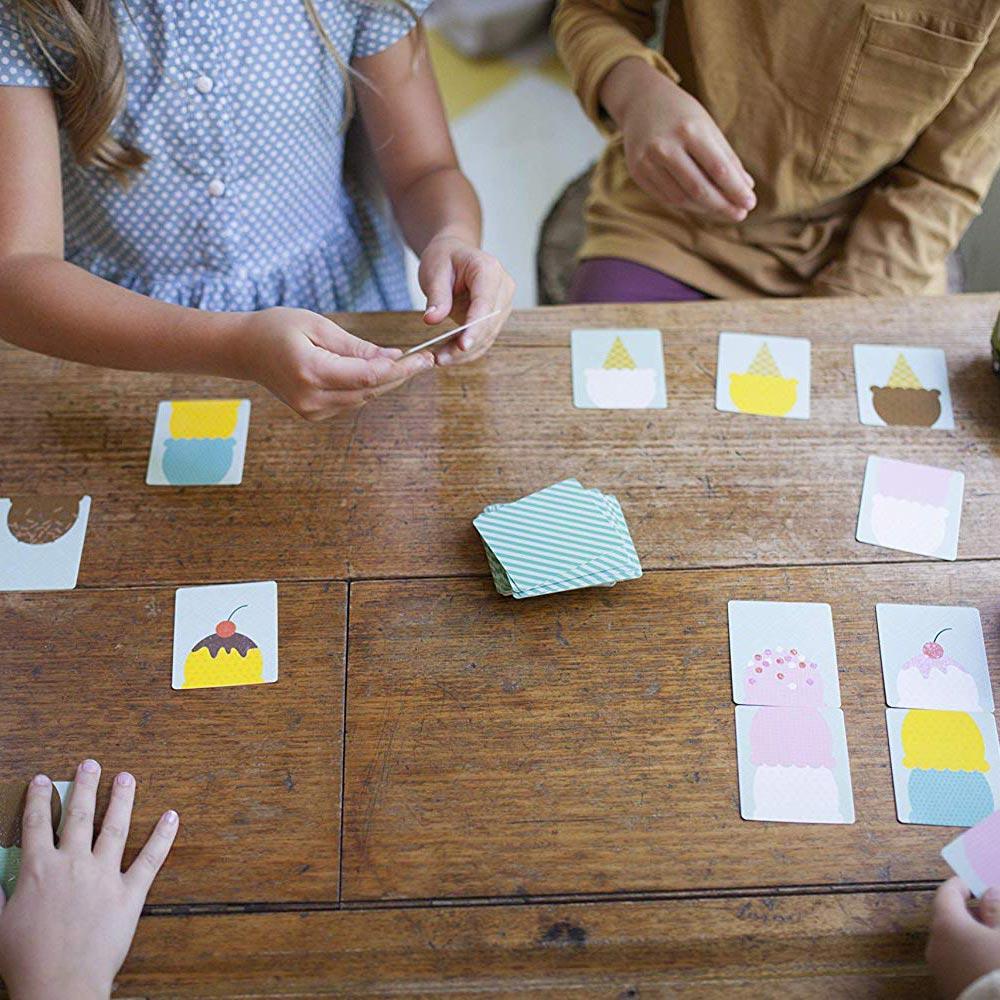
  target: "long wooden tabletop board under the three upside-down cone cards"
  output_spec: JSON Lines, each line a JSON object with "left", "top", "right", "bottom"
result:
{"left": 0, "top": 295, "right": 1000, "bottom": 587}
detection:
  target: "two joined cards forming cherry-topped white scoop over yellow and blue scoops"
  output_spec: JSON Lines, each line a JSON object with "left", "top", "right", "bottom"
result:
{"left": 875, "top": 604, "right": 1000, "bottom": 826}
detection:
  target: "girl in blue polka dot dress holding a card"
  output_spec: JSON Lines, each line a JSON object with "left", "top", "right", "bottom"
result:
{"left": 0, "top": 0, "right": 513, "bottom": 419}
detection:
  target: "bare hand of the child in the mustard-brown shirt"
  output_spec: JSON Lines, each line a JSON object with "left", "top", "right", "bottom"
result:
{"left": 601, "top": 59, "right": 757, "bottom": 222}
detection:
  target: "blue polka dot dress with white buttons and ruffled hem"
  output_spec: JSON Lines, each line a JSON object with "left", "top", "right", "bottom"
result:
{"left": 0, "top": 0, "right": 430, "bottom": 312}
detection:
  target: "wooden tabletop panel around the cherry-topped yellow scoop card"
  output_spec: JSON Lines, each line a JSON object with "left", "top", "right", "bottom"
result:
{"left": 0, "top": 584, "right": 347, "bottom": 903}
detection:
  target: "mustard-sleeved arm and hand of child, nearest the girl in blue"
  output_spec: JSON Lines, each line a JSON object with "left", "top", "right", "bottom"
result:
{"left": 553, "top": 0, "right": 757, "bottom": 222}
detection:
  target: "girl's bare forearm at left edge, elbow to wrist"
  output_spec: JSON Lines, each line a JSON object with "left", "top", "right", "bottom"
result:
{"left": 0, "top": 254, "right": 248, "bottom": 377}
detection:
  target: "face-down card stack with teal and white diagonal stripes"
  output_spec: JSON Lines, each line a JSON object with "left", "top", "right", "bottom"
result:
{"left": 472, "top": 479, "right": 642, "bottom": 598}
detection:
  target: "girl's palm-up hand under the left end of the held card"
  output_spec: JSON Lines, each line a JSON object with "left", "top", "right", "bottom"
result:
{"left": 237, "top": 308, "right": 434, "bottom": 420}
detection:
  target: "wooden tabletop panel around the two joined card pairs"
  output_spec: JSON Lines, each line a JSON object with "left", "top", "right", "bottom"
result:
{"left": 343, "top": 563, "right": 1000, "bottom": 900}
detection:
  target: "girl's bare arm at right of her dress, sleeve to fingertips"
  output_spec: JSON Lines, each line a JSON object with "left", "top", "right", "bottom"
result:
{"left": 355, "top": 32, "right": 514, "bottom": 372}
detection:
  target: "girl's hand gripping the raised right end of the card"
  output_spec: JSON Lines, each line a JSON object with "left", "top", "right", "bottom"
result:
{"left": 419, "top": 236, "right": 514, "bottom": 365}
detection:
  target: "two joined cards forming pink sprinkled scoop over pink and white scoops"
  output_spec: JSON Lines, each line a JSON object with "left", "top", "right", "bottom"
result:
{"left": 729, "top": 601, "right": 854, "bottom": 823}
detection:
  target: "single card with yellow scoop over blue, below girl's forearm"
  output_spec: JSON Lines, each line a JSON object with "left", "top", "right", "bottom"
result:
{"left": 146, "top": 399, "right": 250, "bottom": 486}
